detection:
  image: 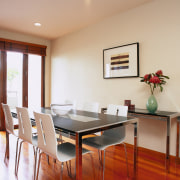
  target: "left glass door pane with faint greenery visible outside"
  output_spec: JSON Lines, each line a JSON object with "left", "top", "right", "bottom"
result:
{"left": 7, "top": 52, "right": 23, "bottom": 108}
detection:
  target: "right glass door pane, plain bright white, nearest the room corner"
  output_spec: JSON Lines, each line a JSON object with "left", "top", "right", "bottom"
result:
{"left": 28, "top": 55, "right": 41, "bottom": 108}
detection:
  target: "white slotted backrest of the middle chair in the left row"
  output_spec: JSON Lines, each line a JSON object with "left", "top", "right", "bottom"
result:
{"left": 16, "top": 107, "right": 32, "bottom": 143}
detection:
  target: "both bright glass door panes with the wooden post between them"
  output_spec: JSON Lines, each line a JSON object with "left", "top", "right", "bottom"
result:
{"left": 7, "top": 52, "right": 42, "bottom": 108}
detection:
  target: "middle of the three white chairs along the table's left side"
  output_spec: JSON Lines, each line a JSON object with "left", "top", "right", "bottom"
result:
{"left": 15, "top": 107, "right": 38, "bottom": 179}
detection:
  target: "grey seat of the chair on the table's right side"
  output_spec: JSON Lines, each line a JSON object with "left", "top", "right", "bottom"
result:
{"left": 83, "top": 135, "right": 124, "bottom": 150}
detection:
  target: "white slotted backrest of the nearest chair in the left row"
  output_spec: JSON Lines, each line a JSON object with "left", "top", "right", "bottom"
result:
{"left": 34, "top": 112, "right": 57, "bottom": 158}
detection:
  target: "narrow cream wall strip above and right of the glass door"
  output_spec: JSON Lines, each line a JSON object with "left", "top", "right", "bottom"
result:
{"left": 0, "top": 29, "right": 51, "bottom": 106}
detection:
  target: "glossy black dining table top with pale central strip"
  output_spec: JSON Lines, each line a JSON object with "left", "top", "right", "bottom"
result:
{"left": 11, "top": 108, "right": 138, "bottom": 135}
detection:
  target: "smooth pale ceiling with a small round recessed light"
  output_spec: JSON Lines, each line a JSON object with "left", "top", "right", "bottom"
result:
{"left": 0, "top": 0, "right": 152, "bottom": 39}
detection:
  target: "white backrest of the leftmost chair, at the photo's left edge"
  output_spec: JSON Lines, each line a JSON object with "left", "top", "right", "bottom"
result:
{"left": 1, "top": 103, "right": 14, "bottom": 134}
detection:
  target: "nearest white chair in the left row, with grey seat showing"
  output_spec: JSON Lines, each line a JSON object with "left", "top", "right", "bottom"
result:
{"left": 34, "top": 112, "right": 90, "bottom": 180}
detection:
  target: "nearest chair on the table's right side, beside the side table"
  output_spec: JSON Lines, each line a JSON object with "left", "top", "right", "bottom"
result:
{"left": 83, "top": 104, "right": 129, "bottom": 179}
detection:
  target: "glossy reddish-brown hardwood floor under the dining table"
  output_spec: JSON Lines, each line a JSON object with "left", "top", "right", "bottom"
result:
{"left": 0, "top": 131, "right": 180, "bottom": 180}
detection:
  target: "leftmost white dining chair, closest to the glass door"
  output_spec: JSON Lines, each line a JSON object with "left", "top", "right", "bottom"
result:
{"left": 1, "top": 103, "right": 19, "bottom": 174}
